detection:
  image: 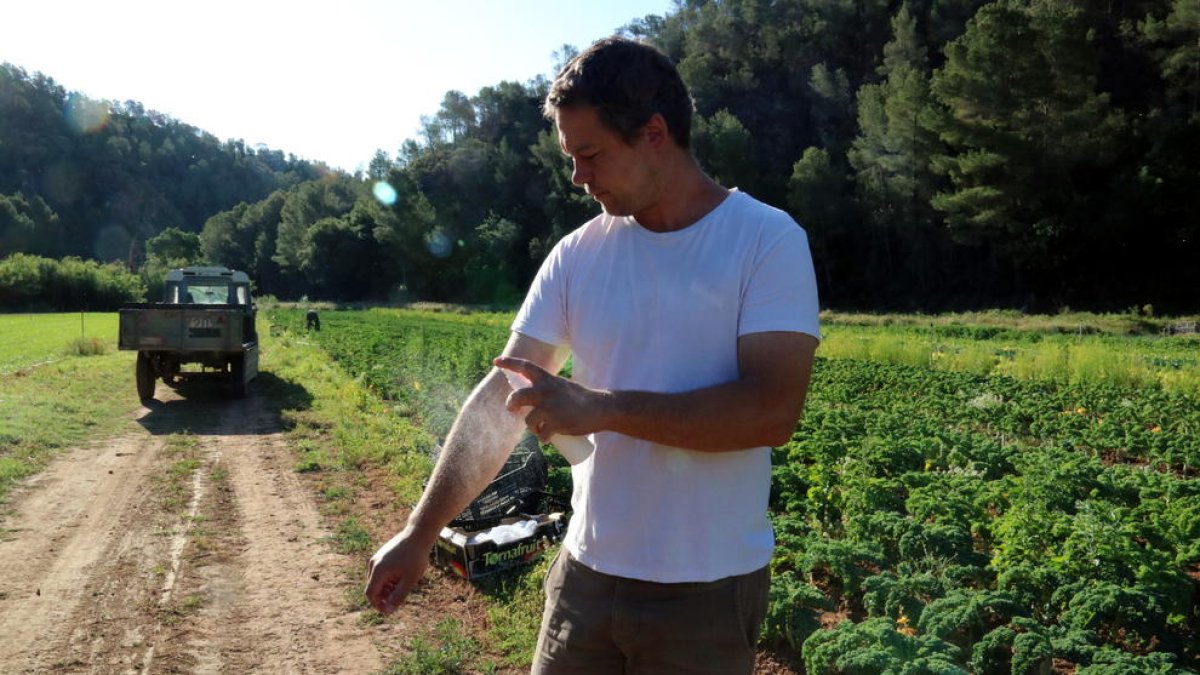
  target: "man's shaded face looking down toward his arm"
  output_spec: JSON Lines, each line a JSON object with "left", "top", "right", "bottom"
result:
{"left": 554, "top": 106, "right": 653, "bottom": 216}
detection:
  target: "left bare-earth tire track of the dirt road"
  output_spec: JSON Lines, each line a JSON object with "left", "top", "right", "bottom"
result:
{"left": 0, "top": 427, "right": 163, "bottom": 673}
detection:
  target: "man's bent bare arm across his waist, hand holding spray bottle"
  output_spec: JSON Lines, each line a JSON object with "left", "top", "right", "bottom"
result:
{"left": 497, "top": 331, "right": 817, "bottom": 452}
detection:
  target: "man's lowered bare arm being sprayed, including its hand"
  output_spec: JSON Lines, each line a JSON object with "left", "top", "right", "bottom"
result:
{"left": 366, "top": 334, "right": 565, "bottom": 614}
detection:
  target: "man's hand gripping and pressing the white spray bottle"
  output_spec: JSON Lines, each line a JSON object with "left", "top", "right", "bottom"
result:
{"left": 492, "top": 357, "right": 605, "bottom": 443}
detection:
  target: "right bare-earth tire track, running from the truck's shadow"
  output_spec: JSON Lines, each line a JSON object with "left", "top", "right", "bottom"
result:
{"left": 154, "top": 391, "right": 384, "bottom": 673}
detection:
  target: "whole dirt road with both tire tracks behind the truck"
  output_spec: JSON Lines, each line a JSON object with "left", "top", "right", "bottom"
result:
{"left": 0, "top": 386, "right": 404, "bottom": 674}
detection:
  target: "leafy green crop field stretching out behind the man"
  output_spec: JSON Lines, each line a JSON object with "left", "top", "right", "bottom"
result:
{"left": 270, "top": 310, "right": 1200, "bottom": 675}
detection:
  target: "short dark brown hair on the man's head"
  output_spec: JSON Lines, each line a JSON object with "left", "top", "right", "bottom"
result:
{"left": 542, "top": 37, "right": 694, "bottom": 149}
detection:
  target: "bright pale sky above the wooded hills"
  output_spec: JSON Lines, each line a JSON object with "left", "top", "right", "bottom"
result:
{"left": 0, "top": 0, "right": 674, "bottom": 172}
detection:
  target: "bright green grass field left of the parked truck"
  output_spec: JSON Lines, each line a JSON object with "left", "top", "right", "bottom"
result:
{"left": 0, "top": 312, "right": 116, "bottom": 375}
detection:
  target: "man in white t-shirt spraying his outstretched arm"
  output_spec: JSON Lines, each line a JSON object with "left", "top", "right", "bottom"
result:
{"left": 366, "top": 38, "right": 818, "bottom": 674}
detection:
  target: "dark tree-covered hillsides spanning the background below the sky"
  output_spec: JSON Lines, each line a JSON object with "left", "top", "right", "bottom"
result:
{"left": 0, "top": 0, "right": 1200, "bottom": 312}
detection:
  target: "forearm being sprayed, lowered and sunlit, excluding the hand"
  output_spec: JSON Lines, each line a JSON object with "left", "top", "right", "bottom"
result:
{"left": 408, "top": 371, "right": 523, "bottom": 543}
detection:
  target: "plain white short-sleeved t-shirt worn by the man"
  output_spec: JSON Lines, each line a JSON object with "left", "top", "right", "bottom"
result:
{"left": 512, "top": 191, "right": 820, "bottom": 583}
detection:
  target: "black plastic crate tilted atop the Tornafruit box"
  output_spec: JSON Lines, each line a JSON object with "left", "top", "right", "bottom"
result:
{"left": 450, "top": 434, "right": 548, "bottom": 532}
